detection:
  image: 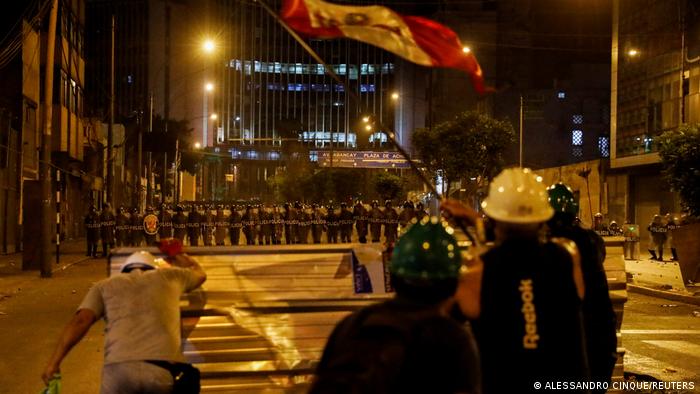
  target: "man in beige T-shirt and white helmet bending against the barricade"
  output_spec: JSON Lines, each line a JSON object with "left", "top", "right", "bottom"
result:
{"left": 42, "top": 242, "right": 206, "bottom": 394}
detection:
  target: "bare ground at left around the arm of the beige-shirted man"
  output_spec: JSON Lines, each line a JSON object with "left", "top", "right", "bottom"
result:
{"left": 0, "top": 240, "right": 106, "bottom": 394}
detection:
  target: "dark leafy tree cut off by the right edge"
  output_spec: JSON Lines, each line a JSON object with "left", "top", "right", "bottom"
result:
{"left": 659, "top": 124, "right": 700, "bottom": 218}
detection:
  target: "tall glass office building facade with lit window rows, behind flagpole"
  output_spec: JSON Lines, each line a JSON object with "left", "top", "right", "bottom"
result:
{"left": 212, "top": 0, "right": 394, "bottom": 149}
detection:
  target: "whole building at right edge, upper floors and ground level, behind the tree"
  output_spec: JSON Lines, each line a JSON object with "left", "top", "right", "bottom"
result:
{"left": 608, "top": 0, "right": 700, "bottom": 234}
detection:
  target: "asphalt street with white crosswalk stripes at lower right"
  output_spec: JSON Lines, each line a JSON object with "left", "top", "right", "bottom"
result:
{"left": 622, "top": 293, "right": 700, "bottom": 393}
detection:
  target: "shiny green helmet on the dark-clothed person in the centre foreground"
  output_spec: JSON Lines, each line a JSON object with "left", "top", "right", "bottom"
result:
{"left": 390, "top": 217, "right": 462, "bottom": 280}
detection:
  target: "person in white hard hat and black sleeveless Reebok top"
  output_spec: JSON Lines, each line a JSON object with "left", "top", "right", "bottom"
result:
{"left": 442, "top": 168, "right": 589, "bottom": 393}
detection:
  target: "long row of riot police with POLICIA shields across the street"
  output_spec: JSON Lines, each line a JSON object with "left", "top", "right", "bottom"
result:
{"left": 85, "top": 200, "right": 427, "bottom": 257}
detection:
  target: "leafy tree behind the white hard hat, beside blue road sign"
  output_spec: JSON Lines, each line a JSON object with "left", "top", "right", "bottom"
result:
{"left": 413, "top": 111, "right": 515, "bottom": 196}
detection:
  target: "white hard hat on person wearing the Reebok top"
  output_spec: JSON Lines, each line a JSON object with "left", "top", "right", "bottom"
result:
{"left": 481, "top": 168, "right": 554, "bottom": 224}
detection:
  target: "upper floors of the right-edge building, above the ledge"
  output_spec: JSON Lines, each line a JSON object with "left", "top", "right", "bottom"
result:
{"left": 611, "top": 0, "right": 700, "bottom": 168}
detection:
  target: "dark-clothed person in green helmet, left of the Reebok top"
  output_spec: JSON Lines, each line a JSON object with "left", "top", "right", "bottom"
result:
{"left": 310, "top": 218, "right": 482, "bottom": 393}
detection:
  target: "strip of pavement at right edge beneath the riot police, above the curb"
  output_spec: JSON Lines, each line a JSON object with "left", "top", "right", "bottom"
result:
{"left": 625, "top": 259, "right": 700, "bottom": 305}
